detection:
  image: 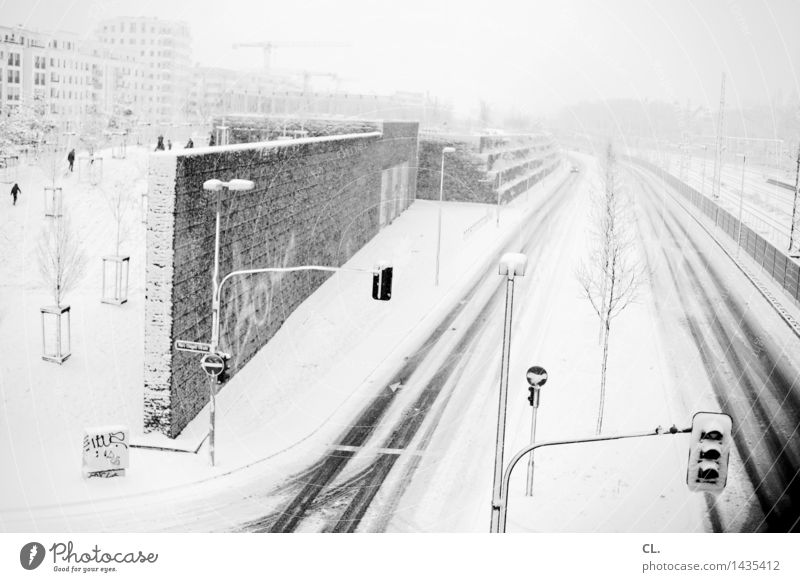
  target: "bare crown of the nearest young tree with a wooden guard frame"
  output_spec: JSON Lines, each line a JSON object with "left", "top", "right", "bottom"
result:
{"left": 37, "top": 215, "right": 86, "bottom": 306}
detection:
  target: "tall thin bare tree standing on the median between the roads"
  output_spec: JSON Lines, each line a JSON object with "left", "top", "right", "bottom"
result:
{"left": 577, "top": 145, "right": 643, "bottom": 434}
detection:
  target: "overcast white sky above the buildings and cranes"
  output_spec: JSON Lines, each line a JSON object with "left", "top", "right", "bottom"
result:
{"left": 0, "top": 0, "right": 800, "bottom": 114}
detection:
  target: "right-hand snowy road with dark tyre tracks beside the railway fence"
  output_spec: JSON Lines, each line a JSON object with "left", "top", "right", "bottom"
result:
{"left": 630, "top": 164, "right": 800, "bottom": 531}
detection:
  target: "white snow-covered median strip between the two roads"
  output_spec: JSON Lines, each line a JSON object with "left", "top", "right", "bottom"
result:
{"left": 376, "top": 158, "right": 709, "bottom": 532}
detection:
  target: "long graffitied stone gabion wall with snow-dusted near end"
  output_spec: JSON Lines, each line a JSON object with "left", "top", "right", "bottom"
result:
{"left": 144, "top": 122, "right": 418, "bottom": 437}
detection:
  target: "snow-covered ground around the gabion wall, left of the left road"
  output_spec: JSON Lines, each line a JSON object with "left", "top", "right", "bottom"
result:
{"left": 0, "top": 154, "right": 569, "bottom": 531}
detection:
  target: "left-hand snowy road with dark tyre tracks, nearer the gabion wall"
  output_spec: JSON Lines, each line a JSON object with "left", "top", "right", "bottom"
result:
{"left": 243, "top": 163, "right": 588, "bottom": 532}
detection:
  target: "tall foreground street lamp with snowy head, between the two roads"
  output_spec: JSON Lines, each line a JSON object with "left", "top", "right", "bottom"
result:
{"left": 491, "top": 253, "right": 528, "bottom": 531}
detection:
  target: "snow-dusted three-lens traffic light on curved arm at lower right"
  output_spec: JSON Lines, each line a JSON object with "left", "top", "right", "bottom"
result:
{"left": 686, "top": 412, "right": 733, "bottom": 493}
